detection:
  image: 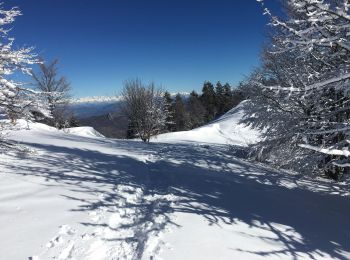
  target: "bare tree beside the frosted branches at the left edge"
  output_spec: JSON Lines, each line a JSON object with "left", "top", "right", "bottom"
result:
{"left": 32, "top": 59, "right": 74, "bottom": 128}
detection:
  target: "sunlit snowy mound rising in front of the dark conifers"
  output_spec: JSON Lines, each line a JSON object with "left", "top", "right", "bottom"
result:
{"left": 153, "top": 102, "right": 259, "bottom": 146}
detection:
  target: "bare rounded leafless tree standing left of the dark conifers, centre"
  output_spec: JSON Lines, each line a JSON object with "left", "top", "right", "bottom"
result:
{"left": 122, "top": 79, "right": 168, "bottom": 142}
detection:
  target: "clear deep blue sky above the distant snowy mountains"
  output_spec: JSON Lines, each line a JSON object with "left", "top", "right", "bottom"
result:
{"left": 5, "top": 0, "right": 278, "bottom": 97}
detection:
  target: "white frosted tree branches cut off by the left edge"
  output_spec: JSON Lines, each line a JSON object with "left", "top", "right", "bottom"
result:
{"left": 0, "top": 3, "right": 47, "bottom": 142}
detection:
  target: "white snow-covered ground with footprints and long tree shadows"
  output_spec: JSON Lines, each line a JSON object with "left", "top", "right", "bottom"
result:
{"left": 0, "top": 108, "right": 350, "bottom": 260}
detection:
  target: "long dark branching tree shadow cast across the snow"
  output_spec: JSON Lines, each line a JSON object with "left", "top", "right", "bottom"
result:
{"left": 6, "top": 140, "right": 350, "bottom": 259}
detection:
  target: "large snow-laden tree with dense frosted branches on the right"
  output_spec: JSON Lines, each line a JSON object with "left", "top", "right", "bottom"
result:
{"left": 245, "top": 0, "right": 350, "bottom": 177}
